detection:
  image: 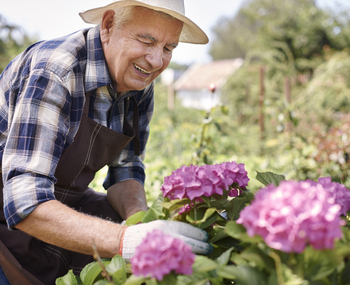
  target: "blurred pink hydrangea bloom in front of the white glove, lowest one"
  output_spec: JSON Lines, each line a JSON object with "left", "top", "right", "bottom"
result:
{"left": 130, "top": 230, "right": 196, "bottom": 281}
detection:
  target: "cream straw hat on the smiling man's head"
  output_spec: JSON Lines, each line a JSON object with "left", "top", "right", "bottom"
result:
{"left": 79, "top": 0, "right": 209, "bottom": 44}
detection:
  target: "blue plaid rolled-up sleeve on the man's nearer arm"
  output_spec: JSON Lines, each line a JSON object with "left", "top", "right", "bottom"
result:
{"left": 2, "top": 69, "right": 70, "bottom": 229}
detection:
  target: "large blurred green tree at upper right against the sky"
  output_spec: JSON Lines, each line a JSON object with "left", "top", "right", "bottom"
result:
{"left": 210, "top": 0, "right": 350, "bottom": 71}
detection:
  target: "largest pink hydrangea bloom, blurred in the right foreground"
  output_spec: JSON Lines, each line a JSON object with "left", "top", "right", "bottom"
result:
{"left": 237, "top": 181, "right": 344, "bottom": 253}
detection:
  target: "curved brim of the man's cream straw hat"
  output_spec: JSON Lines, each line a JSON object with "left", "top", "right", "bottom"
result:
{"left": 79, "top": 0, "right": 209, "bottom": 44}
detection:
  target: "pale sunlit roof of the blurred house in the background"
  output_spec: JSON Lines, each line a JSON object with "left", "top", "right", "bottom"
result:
{"left": 174, "top": 58, "right": 243, "bottom": 90}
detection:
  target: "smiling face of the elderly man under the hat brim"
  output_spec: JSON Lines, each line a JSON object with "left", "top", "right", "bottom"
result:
{"left": 101, "top": 7, "right": 183, "bottom": 92}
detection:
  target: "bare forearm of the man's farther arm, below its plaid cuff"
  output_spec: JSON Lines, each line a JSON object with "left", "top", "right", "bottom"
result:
{"left": 107, "top": 179, "right": 148, "bottom": 220}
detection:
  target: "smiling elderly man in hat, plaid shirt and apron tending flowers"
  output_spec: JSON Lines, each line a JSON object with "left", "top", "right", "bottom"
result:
{"left": 0, "top": 0, "right": 210, "bottom": 285}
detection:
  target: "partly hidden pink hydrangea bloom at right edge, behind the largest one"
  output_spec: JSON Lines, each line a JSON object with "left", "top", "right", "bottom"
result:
{"left": 318, "top": 177, "right": 350, "bottom": 216}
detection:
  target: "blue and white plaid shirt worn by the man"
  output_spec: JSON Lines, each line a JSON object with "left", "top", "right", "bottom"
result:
{"left": 0, "top": 26, "right": 153, "bottom": 229}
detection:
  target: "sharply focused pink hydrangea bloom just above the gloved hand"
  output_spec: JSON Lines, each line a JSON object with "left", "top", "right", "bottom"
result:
{"left": 161, "top": 162, "right": 249, "bottom": 200}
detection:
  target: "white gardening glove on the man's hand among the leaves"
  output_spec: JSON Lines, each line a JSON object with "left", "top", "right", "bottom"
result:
{"left": 119, "top": 220, "right": 213, "bottom": 261}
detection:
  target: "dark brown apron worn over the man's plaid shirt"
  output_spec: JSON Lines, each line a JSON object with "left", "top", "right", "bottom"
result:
{"left": 0, "top": 94, "right": 140, "bottom": 285}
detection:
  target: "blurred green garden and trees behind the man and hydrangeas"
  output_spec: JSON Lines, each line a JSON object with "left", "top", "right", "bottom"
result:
{"left": 0, "top": 0, "right": 350, "bottom": 203}
